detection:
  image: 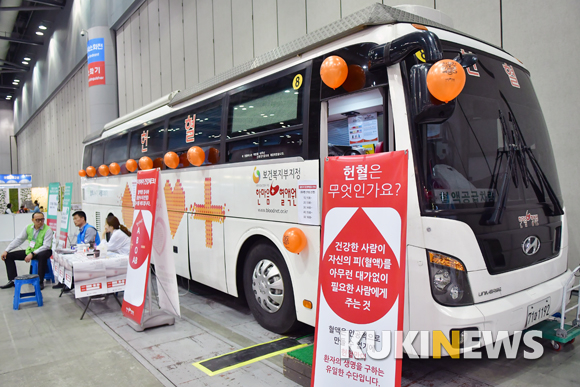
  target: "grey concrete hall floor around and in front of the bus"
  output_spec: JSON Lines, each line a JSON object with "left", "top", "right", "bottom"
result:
{"left": 0, "top": 242, "right": 580, "bottom": 387}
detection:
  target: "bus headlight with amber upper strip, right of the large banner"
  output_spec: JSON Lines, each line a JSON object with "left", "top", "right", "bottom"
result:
{"left": 427, "top": 251, "right": 473, "bottom": 306}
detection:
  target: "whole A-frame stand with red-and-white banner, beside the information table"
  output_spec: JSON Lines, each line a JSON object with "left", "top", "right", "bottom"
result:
{"left": 122, "top": 169, "right": 180, "bottom": 332}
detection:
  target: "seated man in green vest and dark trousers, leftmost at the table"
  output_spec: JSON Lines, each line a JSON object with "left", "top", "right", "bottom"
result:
{"left": 0, "top": 212, "right": 53, "bottom": 290}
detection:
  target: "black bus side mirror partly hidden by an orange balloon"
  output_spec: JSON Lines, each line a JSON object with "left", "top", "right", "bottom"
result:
{"left": 410, "top": 63, "right": 455, "bottom": 124}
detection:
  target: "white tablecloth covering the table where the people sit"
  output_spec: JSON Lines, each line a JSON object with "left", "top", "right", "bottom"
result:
{"left": 52, "top": 252, "right": 129, "bottom": 298}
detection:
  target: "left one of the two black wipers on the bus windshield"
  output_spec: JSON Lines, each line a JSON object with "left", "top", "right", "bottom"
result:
{"left": 486, "top": 110, "right": 518, "bottom": 225}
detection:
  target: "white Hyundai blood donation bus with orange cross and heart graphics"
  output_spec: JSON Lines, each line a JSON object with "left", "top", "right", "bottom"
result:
{"left": 81, "top": 5, "right": 571, "bottom": 354}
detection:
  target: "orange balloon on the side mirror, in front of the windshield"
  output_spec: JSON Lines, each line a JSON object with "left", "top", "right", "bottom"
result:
{"left": 427, "top": 59, "right": 465, "bottom": 103}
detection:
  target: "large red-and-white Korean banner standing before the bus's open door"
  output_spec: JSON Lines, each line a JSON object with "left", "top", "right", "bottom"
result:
{"left": 312, "top": 151, "right": 408, "bottom": 387}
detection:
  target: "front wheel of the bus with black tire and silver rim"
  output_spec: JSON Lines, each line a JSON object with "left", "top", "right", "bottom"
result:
{"left": 243, "top": 242, "right": 300, "bottom": 334}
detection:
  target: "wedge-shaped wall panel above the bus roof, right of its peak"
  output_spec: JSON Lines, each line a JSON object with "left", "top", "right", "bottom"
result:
{"left": 437, "top": 0, "right": 501, "bottom": 46}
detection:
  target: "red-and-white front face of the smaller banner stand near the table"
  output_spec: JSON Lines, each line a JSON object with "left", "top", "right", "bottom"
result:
{"left": 122, "top": 169, "right": 159, "bottom": 324}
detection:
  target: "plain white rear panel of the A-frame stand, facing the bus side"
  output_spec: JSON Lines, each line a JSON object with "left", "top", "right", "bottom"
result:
{"left": 151, "top": 177, "right": 181, "bottom": 316}
